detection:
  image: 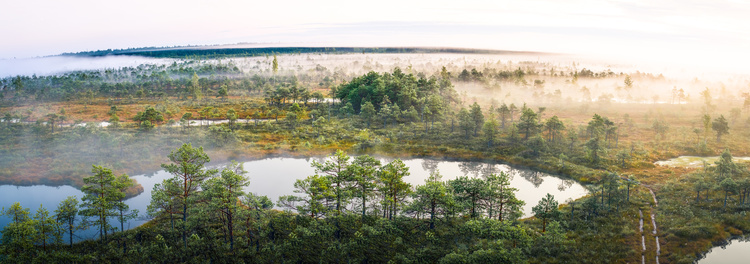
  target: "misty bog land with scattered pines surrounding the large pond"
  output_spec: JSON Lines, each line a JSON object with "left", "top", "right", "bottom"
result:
{"left": 0, "top": 50, "right": 750, "bottom": 263}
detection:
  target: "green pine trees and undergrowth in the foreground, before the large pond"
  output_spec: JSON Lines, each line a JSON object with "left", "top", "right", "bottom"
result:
{"left": 0, "top": 144, "right": 570, "bottom": 263}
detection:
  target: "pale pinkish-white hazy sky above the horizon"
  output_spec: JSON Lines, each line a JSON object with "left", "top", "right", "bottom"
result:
{"left": 0, "top": 0, "right": 750, "bottom": 72}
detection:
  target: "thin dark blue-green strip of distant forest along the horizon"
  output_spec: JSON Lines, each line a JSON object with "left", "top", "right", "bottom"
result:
{"left": 61, "top": 46, "right": 550, "bottom": 58}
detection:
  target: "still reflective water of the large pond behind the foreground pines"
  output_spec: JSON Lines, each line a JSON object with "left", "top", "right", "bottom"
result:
{"left": 0, "top": 158, "right": 587, "bottom": 239}
